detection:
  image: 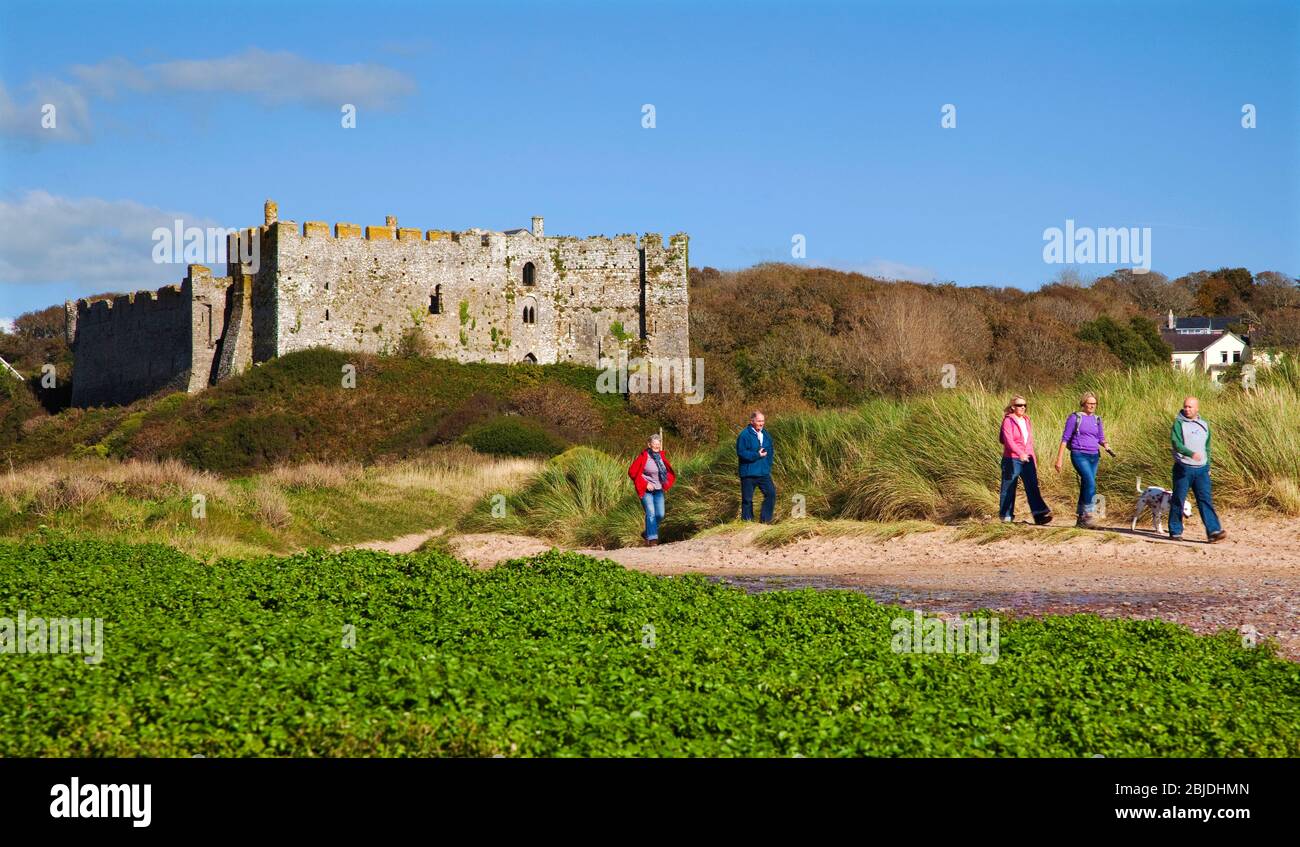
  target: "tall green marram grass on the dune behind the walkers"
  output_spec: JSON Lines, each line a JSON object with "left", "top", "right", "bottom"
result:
{"left": 465, "top": 364, "right": 1300, "bottom": 547}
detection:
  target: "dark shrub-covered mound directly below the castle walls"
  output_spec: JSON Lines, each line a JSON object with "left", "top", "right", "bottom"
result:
{"left": 0, "top": 349, "right": 712, "bottom": 474}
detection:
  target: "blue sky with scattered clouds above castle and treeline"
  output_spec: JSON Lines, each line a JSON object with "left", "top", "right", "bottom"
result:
{"left": 0, "top": 0, "right": 1300, "bottom": 317}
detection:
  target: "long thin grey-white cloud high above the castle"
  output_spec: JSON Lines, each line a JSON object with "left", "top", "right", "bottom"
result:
{"left": 72, "top": 48, "right": 416, "bottom": 108}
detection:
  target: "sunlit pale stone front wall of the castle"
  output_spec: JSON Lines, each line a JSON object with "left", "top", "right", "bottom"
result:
{"left": 271, "top": 216, "right": 686, "bottom": 365}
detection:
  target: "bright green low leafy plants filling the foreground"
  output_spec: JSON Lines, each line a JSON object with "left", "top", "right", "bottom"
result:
{"left": 0, "top": 540, "right": 1300, "bottom": 757}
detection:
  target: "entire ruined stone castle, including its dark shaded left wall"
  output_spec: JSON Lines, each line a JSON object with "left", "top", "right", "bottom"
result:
{"left": 64, "top": 200, "right": 689, "bottom": 407}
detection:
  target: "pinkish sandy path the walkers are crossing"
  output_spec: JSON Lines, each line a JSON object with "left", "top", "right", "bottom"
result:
{"left": 451, "top": 516, "right": 1300, "bottom": 661}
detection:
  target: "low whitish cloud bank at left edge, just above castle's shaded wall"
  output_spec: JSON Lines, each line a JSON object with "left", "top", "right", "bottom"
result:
{"left": 0, "top": 191, "right": 224, "bottom": 294}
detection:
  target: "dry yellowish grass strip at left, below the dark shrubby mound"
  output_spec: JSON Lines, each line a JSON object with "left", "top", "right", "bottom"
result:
{"left": 0, "top": 447, "right": 540, "bottom": 559}
